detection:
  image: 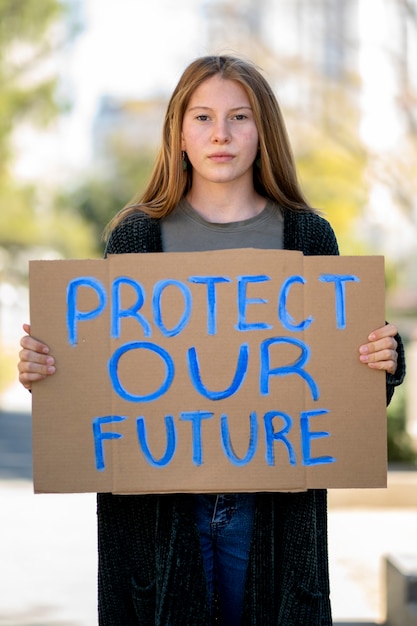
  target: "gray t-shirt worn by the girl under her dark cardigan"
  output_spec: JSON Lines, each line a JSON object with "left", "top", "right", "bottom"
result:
{"left": 162, "top": 199, "right": 284, "bottom": 252}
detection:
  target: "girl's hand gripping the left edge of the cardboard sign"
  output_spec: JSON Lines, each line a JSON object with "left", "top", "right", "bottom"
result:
{"left": 17, "top": 324, "right": 55, "bottom": 389}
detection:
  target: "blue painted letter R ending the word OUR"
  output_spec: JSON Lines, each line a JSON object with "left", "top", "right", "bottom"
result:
{"left": 259, "top": 337, "right": 320, "bottom": 400}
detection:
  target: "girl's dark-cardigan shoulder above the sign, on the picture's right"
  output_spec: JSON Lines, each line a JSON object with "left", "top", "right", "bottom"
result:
{"left": 284, "top": 209, "right": 339, "bottom": 255}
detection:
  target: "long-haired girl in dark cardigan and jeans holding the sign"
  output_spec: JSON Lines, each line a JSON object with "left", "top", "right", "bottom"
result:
{"left": 19, "top": 56, "right": 405, "bottom": 626}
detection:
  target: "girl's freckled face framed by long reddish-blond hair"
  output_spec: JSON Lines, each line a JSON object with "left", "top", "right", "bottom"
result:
{"left": 182, "top": 75, "right": 259, "bottom": 186}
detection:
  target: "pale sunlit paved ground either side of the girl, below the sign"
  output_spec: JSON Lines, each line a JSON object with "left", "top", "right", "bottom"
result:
{"left": 0, "top": 402, "right": 417, "bottom": 626}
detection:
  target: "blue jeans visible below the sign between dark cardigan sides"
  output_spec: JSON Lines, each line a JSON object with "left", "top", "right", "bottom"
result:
{"left": 194, "top": 493, "right": 255, "bottom": 626}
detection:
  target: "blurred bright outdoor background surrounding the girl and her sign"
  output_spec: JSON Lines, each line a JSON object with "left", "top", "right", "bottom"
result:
{"left": 0, "top": 0, "right": 417, "bottom": 626}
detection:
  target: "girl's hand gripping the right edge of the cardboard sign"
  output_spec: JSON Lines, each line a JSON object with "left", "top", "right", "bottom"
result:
{"left": 359, "top": 324, "right": 398, "bottom": 374}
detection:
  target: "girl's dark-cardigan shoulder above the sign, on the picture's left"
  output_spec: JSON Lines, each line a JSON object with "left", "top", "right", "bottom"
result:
{"left": 105, "top": 211, "right": 162, "bottom": 256}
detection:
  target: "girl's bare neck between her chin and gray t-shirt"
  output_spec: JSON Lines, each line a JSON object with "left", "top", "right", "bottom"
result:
{"left": 187, "top": 184, "right": 265, "bottom": 224}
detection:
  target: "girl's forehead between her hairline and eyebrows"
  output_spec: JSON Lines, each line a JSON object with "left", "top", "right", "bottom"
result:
{"left": 187, "top": 74, "right": 250, "bottom": 109}
